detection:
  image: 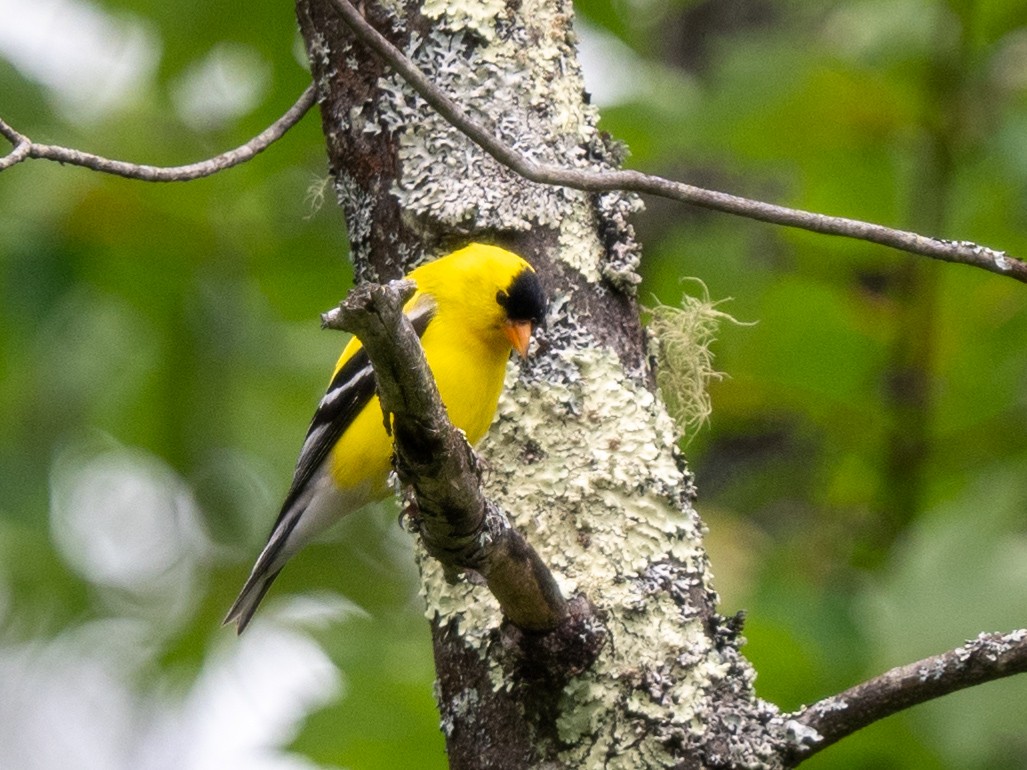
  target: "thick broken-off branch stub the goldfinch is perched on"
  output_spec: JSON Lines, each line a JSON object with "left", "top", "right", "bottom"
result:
{"left": 321, "top": 280, "right": 568, "bottom": 631}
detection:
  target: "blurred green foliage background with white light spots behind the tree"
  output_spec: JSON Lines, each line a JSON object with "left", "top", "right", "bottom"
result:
{"left": 0, "top": 0, "right": 1027, "bottom": 770}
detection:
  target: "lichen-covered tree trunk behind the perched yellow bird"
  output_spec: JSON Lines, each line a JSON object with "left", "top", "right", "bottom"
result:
{"left": 298, "top": 0, "right": 774, "bottom": 768}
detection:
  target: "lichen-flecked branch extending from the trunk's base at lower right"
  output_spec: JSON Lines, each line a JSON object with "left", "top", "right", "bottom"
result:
{"left": 781, "top": 628, "right": 1027, "bottom": 766}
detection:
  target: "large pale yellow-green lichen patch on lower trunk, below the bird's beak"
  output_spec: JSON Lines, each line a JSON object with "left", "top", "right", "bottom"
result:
{"left": 487, "top": 348, "right": 720, "bottom": 766}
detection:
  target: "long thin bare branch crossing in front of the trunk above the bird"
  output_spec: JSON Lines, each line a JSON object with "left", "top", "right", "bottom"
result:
{"left": 331, "top": 0, "right": 1027, "bottom": 283}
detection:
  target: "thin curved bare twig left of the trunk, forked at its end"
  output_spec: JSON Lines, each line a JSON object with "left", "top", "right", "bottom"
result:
{"left": 0, "top": 85, "right": 316, "bottom": 182}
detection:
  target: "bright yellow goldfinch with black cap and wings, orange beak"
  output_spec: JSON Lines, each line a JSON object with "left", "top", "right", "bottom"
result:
{"left": 225, "top": 243, "right": 545, "bottom": 633}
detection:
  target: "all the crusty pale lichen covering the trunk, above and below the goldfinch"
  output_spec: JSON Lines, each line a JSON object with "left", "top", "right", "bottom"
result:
{"left": 340, "top": 0, "right": 772, "bottom": 768}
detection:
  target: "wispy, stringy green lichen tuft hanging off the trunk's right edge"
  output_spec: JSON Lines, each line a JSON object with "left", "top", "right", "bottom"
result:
{"left": 648, "top": 280, "right": 738, "bottom": 440}
